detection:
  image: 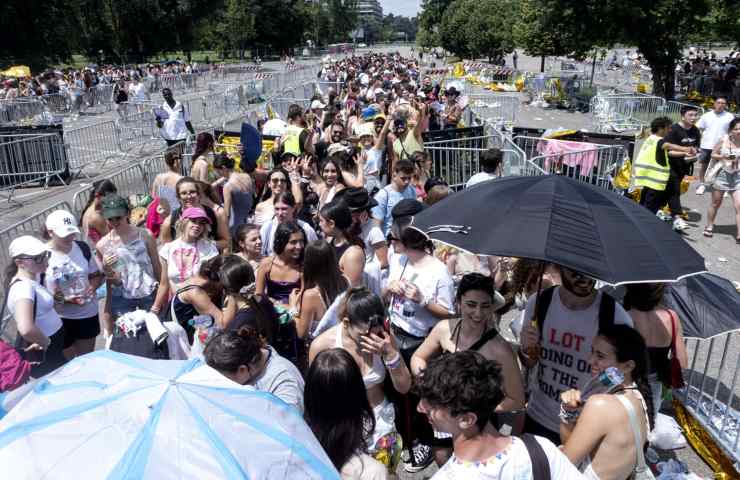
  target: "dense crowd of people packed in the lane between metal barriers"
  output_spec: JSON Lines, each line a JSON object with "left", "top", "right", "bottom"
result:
{"left": 5, "top": 49, "right": 716, "bottom": 480}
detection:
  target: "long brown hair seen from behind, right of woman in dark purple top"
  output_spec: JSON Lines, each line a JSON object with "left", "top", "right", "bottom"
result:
{"left": 299, "top": 240, "right": 348, "bottom": 313}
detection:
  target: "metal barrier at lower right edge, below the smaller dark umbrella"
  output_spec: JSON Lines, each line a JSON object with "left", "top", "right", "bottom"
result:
{"left": 673, "top": 331, "right": 740, "bottom": 470}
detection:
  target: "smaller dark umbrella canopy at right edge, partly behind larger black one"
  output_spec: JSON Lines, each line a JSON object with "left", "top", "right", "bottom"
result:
{"left": 664, "top": 273, "right": 740, "bottom": 338}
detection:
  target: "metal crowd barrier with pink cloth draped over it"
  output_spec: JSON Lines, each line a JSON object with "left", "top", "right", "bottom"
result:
{"left": 513, "top": 136, "right": 625, "bottom": 190}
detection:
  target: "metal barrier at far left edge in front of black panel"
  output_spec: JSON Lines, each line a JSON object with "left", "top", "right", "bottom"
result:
{"left": 0, "top": 133, "right": 67, "bottom": 201}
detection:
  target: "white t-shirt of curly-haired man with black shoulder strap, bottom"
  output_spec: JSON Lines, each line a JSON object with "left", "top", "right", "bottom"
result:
{"left": 432, "top": 436, "right": 585, "bottom": 480}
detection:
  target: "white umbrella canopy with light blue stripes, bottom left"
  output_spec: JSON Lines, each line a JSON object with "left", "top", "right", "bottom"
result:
{"left": 0, "top": 350, "right": 339, "bottom": 480}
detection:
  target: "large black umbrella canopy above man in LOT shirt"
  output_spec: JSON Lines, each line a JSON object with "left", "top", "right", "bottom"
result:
{"left": 413, "top": 175, "right": 705, "bottom": 285}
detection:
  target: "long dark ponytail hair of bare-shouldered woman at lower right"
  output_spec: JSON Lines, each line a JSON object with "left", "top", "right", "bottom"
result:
{"left": 598, "top": 325, "right": 655, "bottom": 429}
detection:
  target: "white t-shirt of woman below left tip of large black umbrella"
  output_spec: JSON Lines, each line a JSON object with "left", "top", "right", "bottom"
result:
{"left": 388, "top": 255, "right": 455, "bottom": 337}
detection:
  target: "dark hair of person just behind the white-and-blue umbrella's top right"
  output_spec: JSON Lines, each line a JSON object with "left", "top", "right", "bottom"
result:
{"left": 203, "top": 327, "right": 265, "bottom": 373}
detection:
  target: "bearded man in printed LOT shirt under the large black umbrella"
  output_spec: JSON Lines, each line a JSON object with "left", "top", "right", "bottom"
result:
{"left": 521, "top": 267, "right": 632, "bottom": 444}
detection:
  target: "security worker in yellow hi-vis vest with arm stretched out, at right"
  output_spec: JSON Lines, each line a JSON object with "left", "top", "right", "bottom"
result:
{"left": 632, "top": 117, "right": 693, "bottom": 213}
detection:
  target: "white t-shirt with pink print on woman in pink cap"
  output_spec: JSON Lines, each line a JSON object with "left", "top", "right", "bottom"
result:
{"left": 159, "top": 238, "right": 218, "bottom": 292}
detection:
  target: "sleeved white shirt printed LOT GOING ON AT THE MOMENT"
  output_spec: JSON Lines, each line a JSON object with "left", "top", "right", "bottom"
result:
{"left": 517, "top": 287, "right": 633, "bottom": 432}
